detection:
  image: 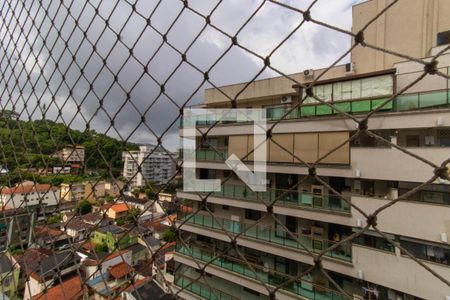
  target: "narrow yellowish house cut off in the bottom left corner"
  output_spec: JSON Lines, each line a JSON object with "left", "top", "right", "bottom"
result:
{"left": 0, "top": 252, "right": 20, "bottom": 299}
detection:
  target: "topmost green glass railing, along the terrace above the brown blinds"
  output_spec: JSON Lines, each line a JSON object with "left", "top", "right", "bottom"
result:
{"left": 180, "top": 90, "right": 450, "bottom": 127}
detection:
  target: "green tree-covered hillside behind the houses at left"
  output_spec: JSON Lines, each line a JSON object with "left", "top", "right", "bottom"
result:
{"left": 0, "top": 111, "right": 138, "bottom": 182}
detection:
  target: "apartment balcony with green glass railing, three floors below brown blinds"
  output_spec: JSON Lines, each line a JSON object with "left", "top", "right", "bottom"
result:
{"left": 175, "top": 244, "right": 347, "bottom": 300}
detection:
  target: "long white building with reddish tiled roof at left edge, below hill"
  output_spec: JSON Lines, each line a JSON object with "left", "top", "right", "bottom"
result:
{"left": 0, "top": 181, "right": 59, "bottom": 208}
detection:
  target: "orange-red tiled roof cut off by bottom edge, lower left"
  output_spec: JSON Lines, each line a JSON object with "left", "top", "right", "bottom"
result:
{"left": 32, "top": 276, "right": 84, "bottom": 300}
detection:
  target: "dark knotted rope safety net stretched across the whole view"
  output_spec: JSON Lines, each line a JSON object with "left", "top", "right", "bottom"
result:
{"left": 0, "top": 0, "right": 450, "bottom": 299}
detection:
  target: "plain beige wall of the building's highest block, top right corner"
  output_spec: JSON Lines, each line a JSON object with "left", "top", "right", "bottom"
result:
{"left": 351, "top": 0, "right": 450, "bottom": 73}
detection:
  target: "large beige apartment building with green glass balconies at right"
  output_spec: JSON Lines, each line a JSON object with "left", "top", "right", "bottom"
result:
{"left": 175, "top": 0, "right": 450, "bottom": 299}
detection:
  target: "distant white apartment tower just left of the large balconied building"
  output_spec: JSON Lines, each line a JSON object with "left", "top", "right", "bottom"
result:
{"left": 122, "top": 145, "right": 175, "bottom": 187}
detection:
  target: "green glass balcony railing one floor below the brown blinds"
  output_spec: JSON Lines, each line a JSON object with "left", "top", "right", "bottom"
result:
{"left": 186, "top": 183, "right": 351, "bottom": 213}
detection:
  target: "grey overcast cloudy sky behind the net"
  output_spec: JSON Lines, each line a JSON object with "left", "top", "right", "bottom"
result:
{"left": 0, "top": 0, "right": 358, "bottom": 150}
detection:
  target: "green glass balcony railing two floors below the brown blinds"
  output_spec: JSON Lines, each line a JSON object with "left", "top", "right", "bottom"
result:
{"left": 178, "top": 212, "right": 352, "bottom": 261}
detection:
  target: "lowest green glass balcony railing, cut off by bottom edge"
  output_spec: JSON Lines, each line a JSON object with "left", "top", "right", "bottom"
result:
{"left": 174, "top": 273, "right": 239, "bottom": 300}
